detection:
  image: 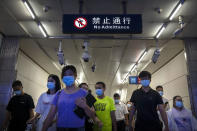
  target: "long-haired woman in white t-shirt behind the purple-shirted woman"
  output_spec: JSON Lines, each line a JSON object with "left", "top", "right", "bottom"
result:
{"left": 31, "top": 74, "right": 61, "bottom": 131}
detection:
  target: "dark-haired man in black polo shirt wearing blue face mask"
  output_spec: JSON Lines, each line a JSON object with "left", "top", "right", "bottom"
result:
{"left": 129, "top": 71, "right": 169, "bottom": 131}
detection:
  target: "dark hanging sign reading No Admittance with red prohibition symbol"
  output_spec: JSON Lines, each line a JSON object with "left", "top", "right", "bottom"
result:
{"left": 62, "top": 14, "right": 142, "bottom": 34}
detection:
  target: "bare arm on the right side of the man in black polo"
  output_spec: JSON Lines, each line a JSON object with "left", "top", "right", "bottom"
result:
{"left": 158, "top": 104, "right": 169, "bottom": 131}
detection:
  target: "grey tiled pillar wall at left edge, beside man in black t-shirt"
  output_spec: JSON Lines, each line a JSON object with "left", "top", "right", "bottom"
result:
{"left": 0, "top": 38, "right": 19, "bottom": 127}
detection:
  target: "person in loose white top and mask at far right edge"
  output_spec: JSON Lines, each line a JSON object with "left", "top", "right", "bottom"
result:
{"left": 167, "top": 96, "right": 197, "bottom": 131}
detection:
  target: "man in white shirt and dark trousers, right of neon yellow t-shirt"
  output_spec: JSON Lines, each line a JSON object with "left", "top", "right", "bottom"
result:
{"left": 114, "top": 93, "right": 129, "bottom": 131}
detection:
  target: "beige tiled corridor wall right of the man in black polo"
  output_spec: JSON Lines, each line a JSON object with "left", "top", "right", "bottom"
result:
{"left": 151, "top": 51, "right": 191, "bottom": 109}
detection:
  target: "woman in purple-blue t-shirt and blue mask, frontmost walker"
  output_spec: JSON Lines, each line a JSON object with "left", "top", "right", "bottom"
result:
{"left": 42, "top": 65, "right": 95, "bottom": 131}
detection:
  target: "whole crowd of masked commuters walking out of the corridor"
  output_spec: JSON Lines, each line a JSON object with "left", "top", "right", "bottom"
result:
{"left": 1, "top": 65, "right": 197, "bottom": 131}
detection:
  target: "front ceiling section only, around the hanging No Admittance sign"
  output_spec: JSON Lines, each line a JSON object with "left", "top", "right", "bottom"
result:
{"left": 0, "top": 0, "right": 197, "bottom": 39}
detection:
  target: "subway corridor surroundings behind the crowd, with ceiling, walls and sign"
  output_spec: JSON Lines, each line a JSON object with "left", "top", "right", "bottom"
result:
{"left": 0, "top": 0, "right": 197, "bottom": 131}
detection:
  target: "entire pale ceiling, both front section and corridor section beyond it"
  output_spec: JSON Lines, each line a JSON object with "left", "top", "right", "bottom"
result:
{"left": 0, "top": 0, "right": 192, "bottom": 93}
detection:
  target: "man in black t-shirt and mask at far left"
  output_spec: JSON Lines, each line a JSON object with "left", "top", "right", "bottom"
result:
{"left": 3, "top": 80, "right": 34, "bottom": 131}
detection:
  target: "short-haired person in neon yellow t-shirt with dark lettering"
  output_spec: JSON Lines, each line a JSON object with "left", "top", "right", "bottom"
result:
{"left": 94, "top": 82, "right": 117, "bottom": 131}
